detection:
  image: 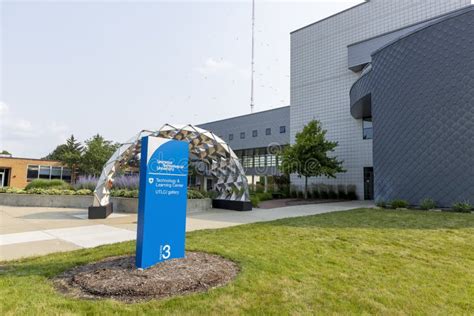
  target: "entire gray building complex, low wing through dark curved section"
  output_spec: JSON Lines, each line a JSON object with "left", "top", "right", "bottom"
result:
{"left": 200, "top": 0, "right": 474, "bottom": 206}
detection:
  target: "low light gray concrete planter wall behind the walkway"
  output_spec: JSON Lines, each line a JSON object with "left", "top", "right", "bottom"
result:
{"left": 0, "top": 193, "right": 212, "bottom": 213}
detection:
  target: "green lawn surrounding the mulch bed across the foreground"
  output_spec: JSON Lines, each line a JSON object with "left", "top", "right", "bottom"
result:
{"left": 0, "top": 209, "right": 474, "bottom": 315}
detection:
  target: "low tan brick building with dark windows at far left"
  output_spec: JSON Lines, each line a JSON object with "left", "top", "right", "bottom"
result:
{"left": 0, "top": 156, "right": 71, "bottom": 189}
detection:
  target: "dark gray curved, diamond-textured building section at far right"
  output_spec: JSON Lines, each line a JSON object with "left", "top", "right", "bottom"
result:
{"left": 350, "top": 6, "right": 474, "bottom": 207}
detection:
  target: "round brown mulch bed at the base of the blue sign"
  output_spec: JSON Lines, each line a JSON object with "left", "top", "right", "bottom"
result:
{"left": 54, "top": 252, "right": 239, "bottom": 302}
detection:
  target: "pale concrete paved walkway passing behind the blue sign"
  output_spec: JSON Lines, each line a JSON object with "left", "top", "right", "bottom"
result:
{"left": 0, "top": 201, "right": 373, "bottom": 260}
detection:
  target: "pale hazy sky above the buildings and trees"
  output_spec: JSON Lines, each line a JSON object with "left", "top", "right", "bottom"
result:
{"left": 0, "top": 0, "right": 363, "bottom": 158}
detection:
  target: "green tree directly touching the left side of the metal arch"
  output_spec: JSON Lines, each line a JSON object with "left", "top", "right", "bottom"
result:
{"left": 81, "top": 134, "right": 118, "bottom": 176}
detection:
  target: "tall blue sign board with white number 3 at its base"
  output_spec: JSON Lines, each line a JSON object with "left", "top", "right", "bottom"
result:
{"left": 135, "top": 136, "right": 189, "bottom": 269}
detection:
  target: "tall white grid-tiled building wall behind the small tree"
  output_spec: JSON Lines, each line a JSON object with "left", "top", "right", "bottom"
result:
{"left": 290, "top": 0, "right": 471, "bottom": 199}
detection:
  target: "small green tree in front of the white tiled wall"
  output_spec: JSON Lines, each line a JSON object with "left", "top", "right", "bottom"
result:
{"left": 280, "top": 120, "right": 345, "bottom": 199}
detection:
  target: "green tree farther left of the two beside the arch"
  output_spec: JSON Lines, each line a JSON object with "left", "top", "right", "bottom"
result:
{"left": 45, "top": 135, "right": 84, "bottom": 181}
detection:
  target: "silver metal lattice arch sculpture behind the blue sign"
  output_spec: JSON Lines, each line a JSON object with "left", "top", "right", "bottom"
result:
{"left": 93, "top": 124, "right": 250, "bottom": 206}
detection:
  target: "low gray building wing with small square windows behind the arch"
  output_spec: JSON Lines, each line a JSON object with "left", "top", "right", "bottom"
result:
{"left": 199, "top": 106, "right": 290, "bottom": 187}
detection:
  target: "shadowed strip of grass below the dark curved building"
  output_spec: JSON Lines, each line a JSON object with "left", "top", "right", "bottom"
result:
{"left": 262, "top": 209, "right": 474, "bottom": 229}
